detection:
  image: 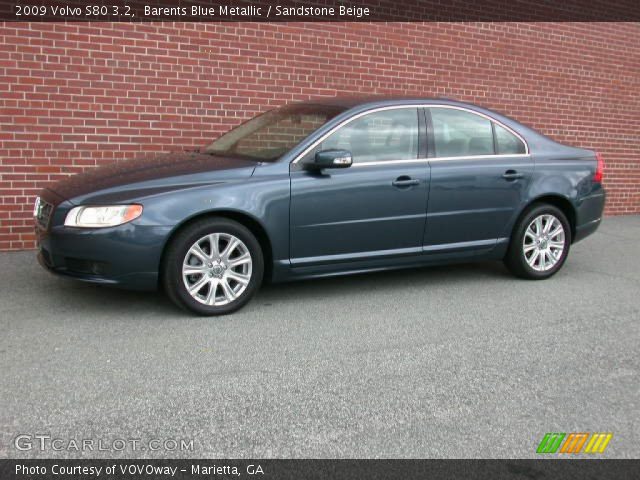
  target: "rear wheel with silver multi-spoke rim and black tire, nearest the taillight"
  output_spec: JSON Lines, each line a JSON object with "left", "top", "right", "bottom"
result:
{"left": 505, "top": 204, "right": 571, "bottom": 280}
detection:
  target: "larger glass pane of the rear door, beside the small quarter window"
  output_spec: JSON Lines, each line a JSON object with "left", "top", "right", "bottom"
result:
{"left": 430, "top": 108, "right": 494, "bottom": 157}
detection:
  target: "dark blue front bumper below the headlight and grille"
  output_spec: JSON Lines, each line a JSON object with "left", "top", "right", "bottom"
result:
{"left": 36, "top": 223, "right": 170, "bottom": 290}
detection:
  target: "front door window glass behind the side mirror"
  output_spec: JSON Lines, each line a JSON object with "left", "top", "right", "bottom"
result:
{"left": 304, "top": 108, "right": 418, "bottom": 163}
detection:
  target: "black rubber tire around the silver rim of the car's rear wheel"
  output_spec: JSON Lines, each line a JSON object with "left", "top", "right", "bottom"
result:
{"left": 504, "top": 203, "right": 571, "bottom": 280}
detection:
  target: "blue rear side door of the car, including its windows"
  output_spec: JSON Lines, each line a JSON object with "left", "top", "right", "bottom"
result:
{"left": 424, "top": 106, "right": 533, "bottom": 252}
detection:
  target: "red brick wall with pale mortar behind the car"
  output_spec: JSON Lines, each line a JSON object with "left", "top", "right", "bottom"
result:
{"left": 0, "top": 23, "right": 640, "bottom": 250}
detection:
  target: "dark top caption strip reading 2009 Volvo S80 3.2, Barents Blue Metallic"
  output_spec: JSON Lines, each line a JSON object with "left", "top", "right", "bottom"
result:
{"left": 0, "top": 0, "right": 640, "bottom": 22}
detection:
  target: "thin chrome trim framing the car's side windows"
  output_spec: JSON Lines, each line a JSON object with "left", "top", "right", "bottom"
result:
{"left": 291, "top": 104, "right": 531, "bottom": 167}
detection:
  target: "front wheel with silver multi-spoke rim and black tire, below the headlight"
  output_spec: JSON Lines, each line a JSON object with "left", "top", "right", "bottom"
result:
{"left": 163, "top": 218, "right": 264, "bottom": 315}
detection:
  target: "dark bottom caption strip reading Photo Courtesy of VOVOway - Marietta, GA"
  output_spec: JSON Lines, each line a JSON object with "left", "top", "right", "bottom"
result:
{"left": 0, "top": 459, "right": 640, "bottom": 480}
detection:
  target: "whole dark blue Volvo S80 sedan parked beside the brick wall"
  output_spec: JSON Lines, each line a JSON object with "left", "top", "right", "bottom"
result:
{"left": 35, "top": 98, "right": 605, "bottom": 315}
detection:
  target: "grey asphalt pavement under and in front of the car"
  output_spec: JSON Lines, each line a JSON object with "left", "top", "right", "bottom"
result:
{"left": 0, "top": 216, "right": 640, "bottom": 458}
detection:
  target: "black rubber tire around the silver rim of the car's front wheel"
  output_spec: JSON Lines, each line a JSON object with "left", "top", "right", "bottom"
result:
{"left": 162, "top": 217, "right": 264, "bottom": 315}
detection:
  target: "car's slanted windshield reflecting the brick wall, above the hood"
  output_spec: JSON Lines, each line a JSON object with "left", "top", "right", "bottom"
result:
{"left": 204, "top": 105, "right": 345, "bottom": 162}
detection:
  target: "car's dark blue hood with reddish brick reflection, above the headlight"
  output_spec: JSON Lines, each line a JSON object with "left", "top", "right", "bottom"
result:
{"left": 49, "top": 153, "right": 256, "bottom": 199}
